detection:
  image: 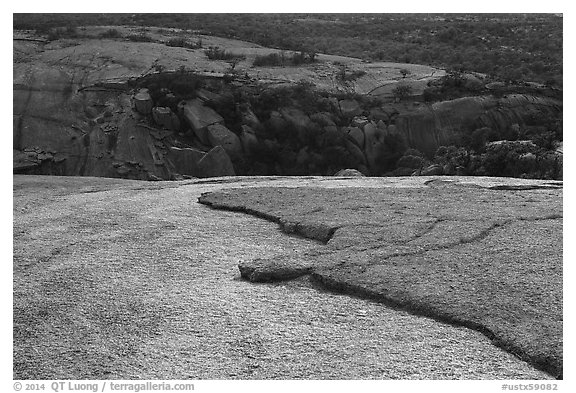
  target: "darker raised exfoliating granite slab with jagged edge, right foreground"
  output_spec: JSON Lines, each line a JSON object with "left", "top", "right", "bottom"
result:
{"left": 199, "top": 177, "right": 562, "bottom": 377}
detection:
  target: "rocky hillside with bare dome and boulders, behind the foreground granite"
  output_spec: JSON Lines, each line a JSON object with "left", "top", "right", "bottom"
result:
{"left": 13, "top": 27, "right": 562, "bottom": 180}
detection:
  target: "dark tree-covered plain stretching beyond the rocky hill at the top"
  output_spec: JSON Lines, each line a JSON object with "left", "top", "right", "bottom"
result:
{"left": 14, "top": 14, "right": 563, "bottom": 86}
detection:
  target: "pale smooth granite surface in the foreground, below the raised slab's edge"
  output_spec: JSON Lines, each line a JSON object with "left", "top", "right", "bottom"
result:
{"left": 13, "top": 176, "right": 549, "bottom": 380}
